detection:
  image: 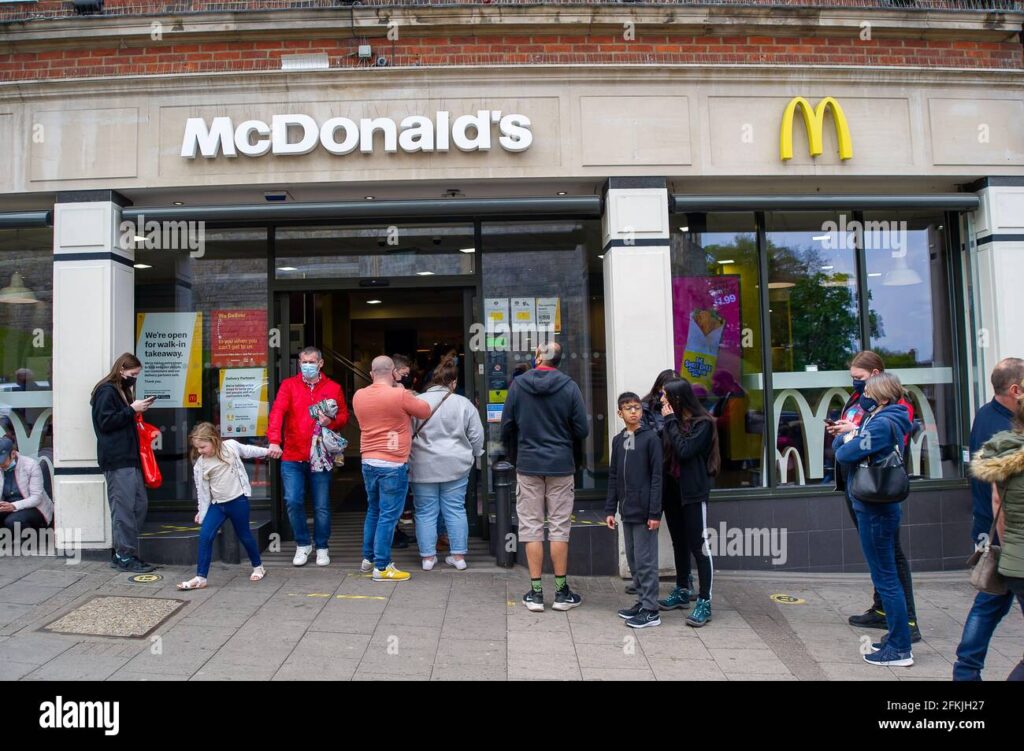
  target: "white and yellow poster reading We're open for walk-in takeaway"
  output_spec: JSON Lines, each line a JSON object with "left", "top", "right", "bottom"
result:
{"left": 135, "top": 312, "right": 203, "bottom": 409}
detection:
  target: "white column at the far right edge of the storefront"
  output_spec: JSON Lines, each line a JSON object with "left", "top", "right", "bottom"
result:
{"left": 969, "top": 177, "right": 1024, "bottom": 406}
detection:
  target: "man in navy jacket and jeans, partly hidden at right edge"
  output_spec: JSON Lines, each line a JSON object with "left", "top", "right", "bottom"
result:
{"left": 953, "top": 358, "right": 1024, "bottom": 680}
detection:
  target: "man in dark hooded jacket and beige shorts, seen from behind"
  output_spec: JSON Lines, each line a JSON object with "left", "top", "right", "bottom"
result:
{"left": 502, "top": 343, "right": 590, "bottom": 613}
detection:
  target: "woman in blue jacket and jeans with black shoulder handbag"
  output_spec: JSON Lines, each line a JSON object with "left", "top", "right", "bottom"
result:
{"left": 833, "top": 373, "right": 913, "bottom": 667}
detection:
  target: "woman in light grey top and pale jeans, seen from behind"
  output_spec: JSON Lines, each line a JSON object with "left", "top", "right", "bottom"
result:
{"left": 409, "top": 358, "right": 483, "bottom": 571}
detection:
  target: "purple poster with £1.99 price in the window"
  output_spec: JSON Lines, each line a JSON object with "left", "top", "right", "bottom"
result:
{"left": 672, "top": 276, "right": 740, "bottom": 393}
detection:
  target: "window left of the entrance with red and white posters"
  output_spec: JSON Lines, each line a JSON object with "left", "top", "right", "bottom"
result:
{"left": 135, "top": 228, "right": 270, "bottom": 502}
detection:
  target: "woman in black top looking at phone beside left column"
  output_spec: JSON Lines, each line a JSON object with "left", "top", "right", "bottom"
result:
{"left": 89, "top": 352, "right": 156, "bottom": 574}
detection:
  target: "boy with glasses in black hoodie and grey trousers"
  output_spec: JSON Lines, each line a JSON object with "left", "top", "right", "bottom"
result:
{"left": 604, "top": 391, "right": 663, "bottom": 628}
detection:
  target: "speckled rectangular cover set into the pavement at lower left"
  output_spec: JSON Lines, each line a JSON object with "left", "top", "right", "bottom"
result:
{"left": 42, "top": 595, "right": 184, "bottom": 638}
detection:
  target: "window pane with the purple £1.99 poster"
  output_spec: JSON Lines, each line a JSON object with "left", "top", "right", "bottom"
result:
{"left": 671, "top": 213, "right": 767, "bottom": 488}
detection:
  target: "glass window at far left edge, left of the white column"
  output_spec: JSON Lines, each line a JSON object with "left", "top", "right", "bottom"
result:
{"left": 0, "top": 227, "right": 53, "bottom": 485}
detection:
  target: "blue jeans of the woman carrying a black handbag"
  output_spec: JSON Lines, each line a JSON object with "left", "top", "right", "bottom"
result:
{"left": 853, "top": 501, "right": 910, "bottom": 653}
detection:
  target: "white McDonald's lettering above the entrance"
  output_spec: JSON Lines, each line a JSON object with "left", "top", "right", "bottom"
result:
{"left": 181, "top": 110, "right": 534, "bottom": 159}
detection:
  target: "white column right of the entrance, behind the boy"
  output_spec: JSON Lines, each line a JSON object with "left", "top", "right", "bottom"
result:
{"left": 601, "top": 177, "right": 675, "bottom": 576}
